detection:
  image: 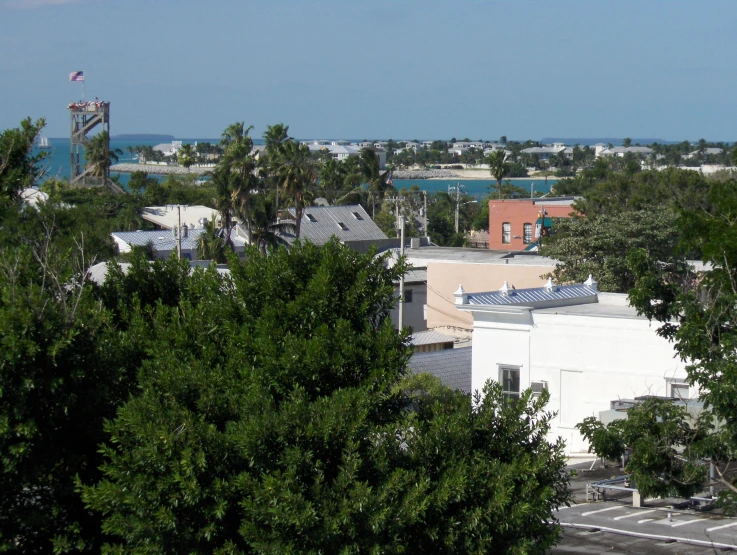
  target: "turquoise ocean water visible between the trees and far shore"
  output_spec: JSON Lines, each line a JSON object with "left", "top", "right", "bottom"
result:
{"left": 34, "top": 138, "right": 556, "bottom": 198}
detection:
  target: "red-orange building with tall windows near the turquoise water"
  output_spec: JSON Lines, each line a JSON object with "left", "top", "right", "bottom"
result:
{"left": 489, "top": 197, "right": 575, "bottom": 251}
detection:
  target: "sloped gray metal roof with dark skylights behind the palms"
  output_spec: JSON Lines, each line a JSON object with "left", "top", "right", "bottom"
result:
{"left": 283, "top": 204, "right": 387, "bottom": 245}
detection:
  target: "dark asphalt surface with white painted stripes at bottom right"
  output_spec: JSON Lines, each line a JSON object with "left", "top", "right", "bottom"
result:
{"left": 552, "top": 501, "right": 737, "bottom": 554}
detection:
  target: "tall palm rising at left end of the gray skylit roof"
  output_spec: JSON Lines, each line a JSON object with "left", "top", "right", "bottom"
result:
{"left": 276, "top": 139, "right": 317, "bottom": 239}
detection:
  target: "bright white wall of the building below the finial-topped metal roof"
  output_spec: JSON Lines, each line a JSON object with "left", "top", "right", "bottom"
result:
{"left": 472, "top": 298, "right": 697, "bottom": 454}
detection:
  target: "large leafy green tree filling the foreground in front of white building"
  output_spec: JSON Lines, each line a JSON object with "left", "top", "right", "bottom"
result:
{"left": 84, "top": 240, "right": 568, "bottom": 553}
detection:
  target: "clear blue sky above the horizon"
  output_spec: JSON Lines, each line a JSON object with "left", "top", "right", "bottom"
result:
{"left": 0, "top": 0, "right": 737, "bottom": 140}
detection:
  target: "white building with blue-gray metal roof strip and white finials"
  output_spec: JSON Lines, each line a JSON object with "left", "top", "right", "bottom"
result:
{"left": 455, "top": 278, "right": 696, "bottom": 454}
